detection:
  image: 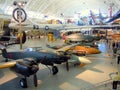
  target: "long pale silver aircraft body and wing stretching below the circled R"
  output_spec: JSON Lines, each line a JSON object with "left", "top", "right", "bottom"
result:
{"left": 9, "top": 20, "right": 120, "bottom": 31}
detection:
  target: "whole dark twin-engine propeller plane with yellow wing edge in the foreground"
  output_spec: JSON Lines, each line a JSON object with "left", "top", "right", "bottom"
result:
{"left": 0, "top": 45, "right": 90, "bottom": 88}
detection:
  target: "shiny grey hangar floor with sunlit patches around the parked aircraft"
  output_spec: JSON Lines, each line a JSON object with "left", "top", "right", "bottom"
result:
{"left": 0, "top": 39, "right": 120, "bottom": 90}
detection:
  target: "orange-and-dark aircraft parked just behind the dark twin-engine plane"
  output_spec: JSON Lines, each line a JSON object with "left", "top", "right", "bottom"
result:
{"left": 47, "top": 43, "right": 101, "bottom": 55}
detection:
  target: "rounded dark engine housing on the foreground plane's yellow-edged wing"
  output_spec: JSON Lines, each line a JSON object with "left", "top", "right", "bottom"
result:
{"left": 12, "top": 59, "right": 39, "bottom": 77}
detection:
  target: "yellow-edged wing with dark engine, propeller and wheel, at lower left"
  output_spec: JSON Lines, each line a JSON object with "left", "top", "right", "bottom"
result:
{"left": 0, "top": 58, "right": 39, "bottom": 88}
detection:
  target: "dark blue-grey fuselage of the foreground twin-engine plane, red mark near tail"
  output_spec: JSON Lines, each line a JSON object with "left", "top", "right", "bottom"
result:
{"left": 7, "top": 51, "right": 65, "bottom": 65}
